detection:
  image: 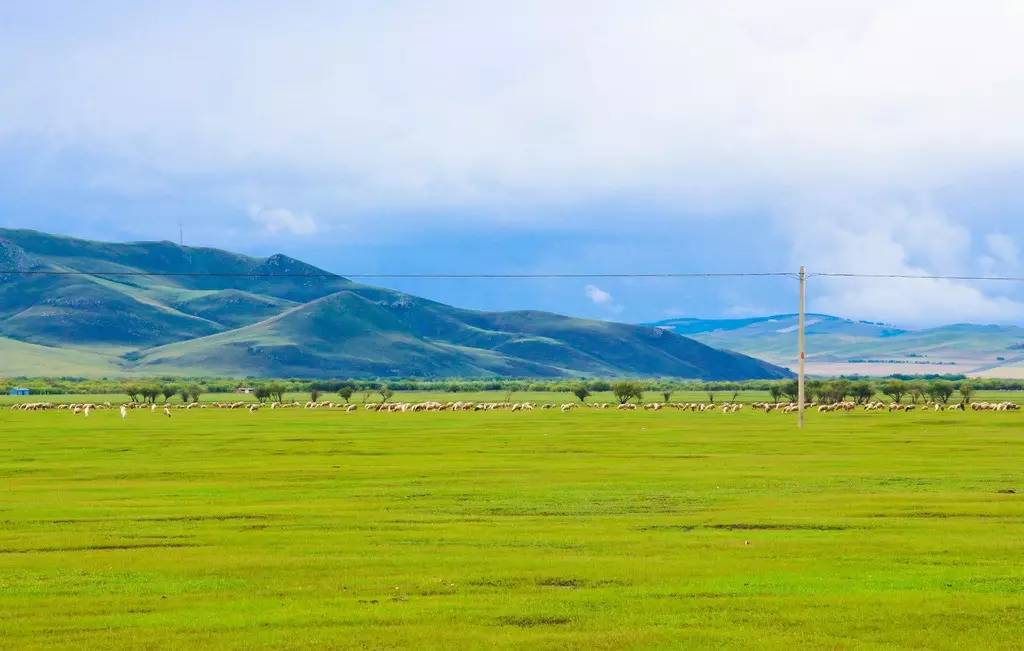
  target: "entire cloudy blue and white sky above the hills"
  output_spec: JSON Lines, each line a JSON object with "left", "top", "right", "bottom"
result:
{"left": 0, "top": 0, "right": 1024, "bottom": 327}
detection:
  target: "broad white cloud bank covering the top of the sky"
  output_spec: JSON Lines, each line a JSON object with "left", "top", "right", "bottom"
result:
{"left": 0, "top": 0, "right": 1024, "bottom": 210}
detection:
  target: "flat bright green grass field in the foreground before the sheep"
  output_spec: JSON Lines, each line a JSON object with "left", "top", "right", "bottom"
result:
{"left": 0, "top": 396, "right": 1024, "bottom": 649}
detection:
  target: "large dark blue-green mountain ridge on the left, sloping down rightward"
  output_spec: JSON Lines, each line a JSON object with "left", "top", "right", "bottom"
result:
{"left": 0, "top": 229, "right": 790, "bottom": 380}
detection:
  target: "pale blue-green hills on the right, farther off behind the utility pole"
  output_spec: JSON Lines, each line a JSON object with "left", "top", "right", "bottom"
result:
{"left": 650, "top": 314, "right": 1024, "bottom": 377}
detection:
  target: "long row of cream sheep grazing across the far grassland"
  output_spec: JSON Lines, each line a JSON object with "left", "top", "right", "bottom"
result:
{"left": 11, "top": 400, "right": 1020, "bottom": 419}
